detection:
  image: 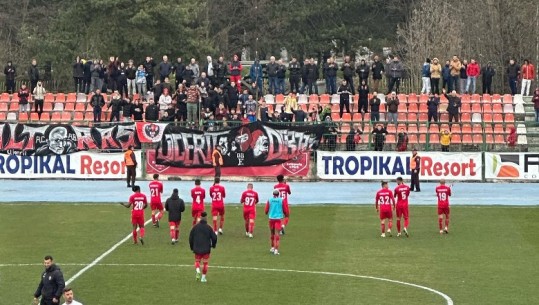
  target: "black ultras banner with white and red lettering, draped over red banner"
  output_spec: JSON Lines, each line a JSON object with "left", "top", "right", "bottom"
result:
{"left": 155, "top": 122, "right": 325, "bottom": 169}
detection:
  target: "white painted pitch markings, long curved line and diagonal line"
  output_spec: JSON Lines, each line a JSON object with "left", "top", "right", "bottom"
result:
{"left": 0, "top": 262, "right": 454, "bottom": 305}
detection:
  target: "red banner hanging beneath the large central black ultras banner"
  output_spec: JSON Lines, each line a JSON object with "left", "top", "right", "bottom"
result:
{"left": 146, "top": 150, "right": 311, "bottom": 177}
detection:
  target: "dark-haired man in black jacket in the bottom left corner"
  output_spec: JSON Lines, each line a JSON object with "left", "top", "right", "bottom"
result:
{"left": 34, "top": 255, "right": 65, "bottom": 305}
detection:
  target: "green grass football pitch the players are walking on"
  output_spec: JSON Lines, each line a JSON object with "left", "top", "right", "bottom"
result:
{"left": 0, "top": 204, "right": 539, "bottom": 305}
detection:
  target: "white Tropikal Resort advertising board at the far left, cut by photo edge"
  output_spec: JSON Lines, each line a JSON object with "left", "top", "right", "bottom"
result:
{"left": 0, "top": 151, "right": 142, "bottom": 179}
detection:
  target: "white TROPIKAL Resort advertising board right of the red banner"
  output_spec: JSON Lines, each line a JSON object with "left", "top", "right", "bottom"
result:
{"left": 317, "top": 151, "right": 482, "bottom": 180}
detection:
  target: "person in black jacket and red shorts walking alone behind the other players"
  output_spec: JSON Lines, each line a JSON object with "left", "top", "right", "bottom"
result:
{"left": 189, "top": 212, "right": 217, "bottom": 283}
